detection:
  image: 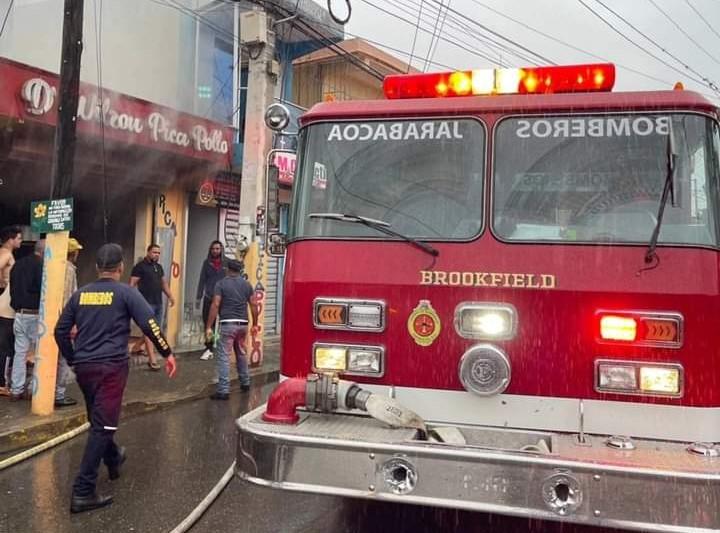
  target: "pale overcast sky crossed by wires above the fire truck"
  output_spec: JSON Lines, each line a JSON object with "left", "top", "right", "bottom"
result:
{"left": 316, "top": 0, "right": 720, "bottom": 103}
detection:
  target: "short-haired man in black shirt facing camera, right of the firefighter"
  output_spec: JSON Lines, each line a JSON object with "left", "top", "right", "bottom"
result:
{"left": 130, "top": 244, "right": 175, "bottom": 370}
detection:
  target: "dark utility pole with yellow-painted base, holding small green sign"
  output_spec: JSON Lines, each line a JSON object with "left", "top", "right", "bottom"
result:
{"left": 32, "top": 0, "right": 84, "bottom": 415}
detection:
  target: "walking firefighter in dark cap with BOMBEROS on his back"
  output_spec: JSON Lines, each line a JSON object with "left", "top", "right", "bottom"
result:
{"left": 55, "top": 244, "right": 176, "bottom": 513}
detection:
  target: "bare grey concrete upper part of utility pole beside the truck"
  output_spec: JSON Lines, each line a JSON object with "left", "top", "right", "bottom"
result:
{"left": 240, "top": 13, "right": 279, "bottom": 242}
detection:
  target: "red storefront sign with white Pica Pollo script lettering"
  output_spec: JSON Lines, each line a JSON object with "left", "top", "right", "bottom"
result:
{"left": 0, "top": 59, "right": 232, "bottom": 164}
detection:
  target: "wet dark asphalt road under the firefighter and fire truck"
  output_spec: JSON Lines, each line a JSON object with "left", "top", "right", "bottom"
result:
{"left": 0, "top": 385, "right": 624, "bottom": 533}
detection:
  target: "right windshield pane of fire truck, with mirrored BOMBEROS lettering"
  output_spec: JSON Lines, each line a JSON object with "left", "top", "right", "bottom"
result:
{"left": 493, "top": 114, "right": 718, "bottom": 246}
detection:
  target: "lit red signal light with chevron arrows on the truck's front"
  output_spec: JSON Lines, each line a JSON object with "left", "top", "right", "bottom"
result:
{"left": 596, "top": 311, "right": 683, "bottom": 348}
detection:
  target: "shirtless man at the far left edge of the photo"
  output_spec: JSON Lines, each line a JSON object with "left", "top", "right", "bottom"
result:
{"left": 0, "top": 226, "right": 22, "bottom": 396}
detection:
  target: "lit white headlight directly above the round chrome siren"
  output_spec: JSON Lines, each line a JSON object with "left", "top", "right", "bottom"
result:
{"left": 455, "top": 302, "right": 517, "bottom": 340}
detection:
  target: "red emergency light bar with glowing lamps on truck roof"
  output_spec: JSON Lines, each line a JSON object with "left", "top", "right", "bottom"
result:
{"left": 383, "top": 63, "right": 615, "bottom": 100}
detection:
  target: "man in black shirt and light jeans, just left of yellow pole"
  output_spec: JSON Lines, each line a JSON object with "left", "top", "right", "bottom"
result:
{"left": 10, "top": 239, "right": 45, "bottom": 401}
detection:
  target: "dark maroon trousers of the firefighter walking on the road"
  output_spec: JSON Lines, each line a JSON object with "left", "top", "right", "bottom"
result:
{"left": 73, "top": 360, "right": 128, "bottom": 496}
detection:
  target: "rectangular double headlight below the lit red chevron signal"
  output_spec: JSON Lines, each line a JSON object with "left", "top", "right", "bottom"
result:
{"left": 595, "top": 359, "right": 683, "bottom": 398}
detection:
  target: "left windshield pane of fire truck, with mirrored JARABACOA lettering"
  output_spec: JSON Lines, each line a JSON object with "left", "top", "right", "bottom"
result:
{"left": 290, "top": 118, "right": 485, "bottom": 241}
